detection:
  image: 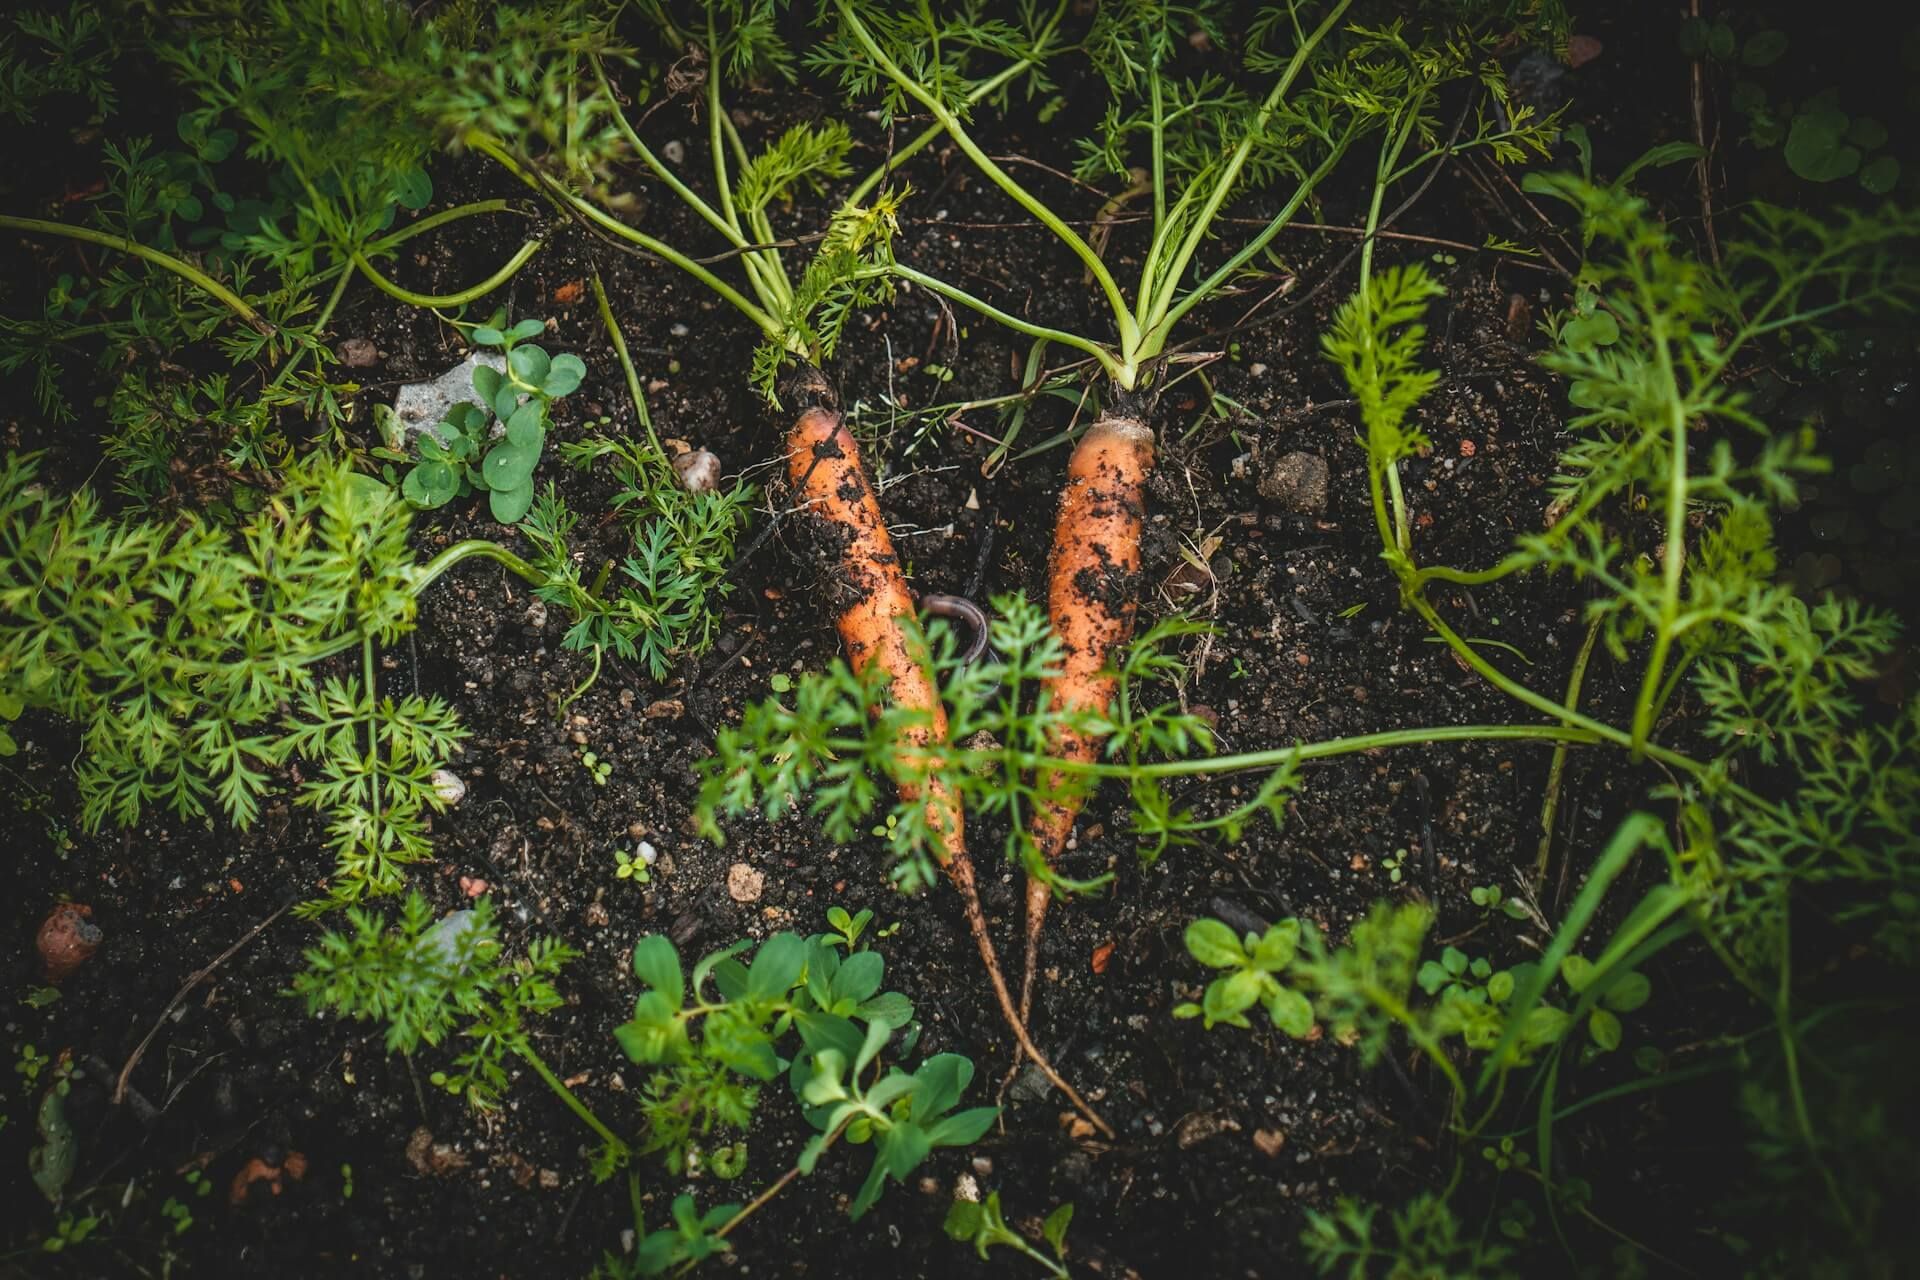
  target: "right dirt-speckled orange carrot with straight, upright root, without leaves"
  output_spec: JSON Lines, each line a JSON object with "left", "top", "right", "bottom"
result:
{"left": 1020, "top": 407, "right": 1154, "bottom": 1021}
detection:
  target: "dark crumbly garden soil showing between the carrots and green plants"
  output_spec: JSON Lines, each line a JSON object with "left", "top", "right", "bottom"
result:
{"left": 0, "top": 5, "right": 1912, "bottom": 1276}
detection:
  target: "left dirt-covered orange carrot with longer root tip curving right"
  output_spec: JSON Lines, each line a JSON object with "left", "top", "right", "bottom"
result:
{"left": 787, "top": 370, "right": 1114, "bottom": 1138}
